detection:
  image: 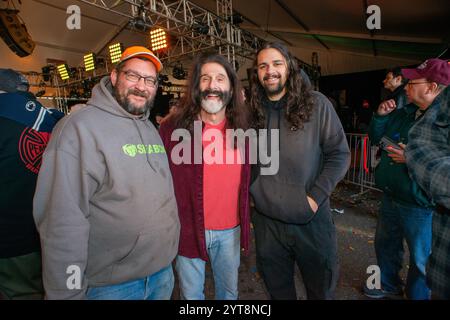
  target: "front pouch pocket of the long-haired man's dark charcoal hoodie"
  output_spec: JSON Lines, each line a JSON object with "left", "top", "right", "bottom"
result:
{"left": 250, "top": 176, "right": 314, "bottom": 224}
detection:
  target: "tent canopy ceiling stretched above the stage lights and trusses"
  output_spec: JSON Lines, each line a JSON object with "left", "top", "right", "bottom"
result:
{"left": 0, "top": 0, "right": 450, "bottom": 78}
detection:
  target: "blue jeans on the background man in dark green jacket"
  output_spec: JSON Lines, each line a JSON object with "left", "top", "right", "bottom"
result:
{"left": 375, "top": 196, "right": 433, "bottom": 300}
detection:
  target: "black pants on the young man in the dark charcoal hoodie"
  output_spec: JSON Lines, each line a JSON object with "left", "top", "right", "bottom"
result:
{"left": 252, "top": 208, "right": 338, "bottom": 300}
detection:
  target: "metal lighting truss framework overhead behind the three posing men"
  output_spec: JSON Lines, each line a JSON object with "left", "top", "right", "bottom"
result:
{"left": 20, "top": 0, "right": 315, "bottom": 113}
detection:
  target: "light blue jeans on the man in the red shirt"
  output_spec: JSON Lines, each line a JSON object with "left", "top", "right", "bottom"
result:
{"left": 175, "top": 226, "right": 241, "bottom": 300}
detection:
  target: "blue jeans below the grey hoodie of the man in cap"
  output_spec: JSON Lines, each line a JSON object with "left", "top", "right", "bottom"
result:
{"left": 86, "top": 265, "right": 175, "bottom": 300}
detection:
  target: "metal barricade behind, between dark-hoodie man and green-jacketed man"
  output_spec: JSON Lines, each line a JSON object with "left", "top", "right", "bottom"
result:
{"left": 344, "top": 133, "right": 381, "bottom": 194}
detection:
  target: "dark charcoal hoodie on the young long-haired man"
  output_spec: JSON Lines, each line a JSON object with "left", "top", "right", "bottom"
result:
{"left": 250, "top": 91, "right": 350, "bottom": 224}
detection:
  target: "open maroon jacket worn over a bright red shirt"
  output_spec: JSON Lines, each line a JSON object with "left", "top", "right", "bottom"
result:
{"left": 159, "top": 120, "right": 251, "bottom": 261}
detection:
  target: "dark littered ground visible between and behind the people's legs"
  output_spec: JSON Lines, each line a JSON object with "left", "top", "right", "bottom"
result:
{"left": 173, "top": 183, "right": 407, "bottom": 300}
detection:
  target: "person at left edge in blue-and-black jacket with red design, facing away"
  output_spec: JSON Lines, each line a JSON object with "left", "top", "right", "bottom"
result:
{"left": 0, "top": 69, "right": 64, "bottom": 299}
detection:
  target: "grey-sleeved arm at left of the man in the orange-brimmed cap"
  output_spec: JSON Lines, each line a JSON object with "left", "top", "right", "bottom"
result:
{"left": 33, "top": 131, "right": 94, "bottom": 299}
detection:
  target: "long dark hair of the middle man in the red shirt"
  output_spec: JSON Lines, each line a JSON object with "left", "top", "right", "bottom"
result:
{"left": 169, "top": 54, "right": 250, "bottom": 132}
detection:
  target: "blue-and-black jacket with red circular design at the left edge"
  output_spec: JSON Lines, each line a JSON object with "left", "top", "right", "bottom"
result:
{"left": 0, "top": 93, "right": 64, "bottom": 259}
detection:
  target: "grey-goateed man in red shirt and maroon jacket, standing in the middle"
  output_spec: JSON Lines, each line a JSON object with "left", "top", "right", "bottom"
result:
{"left": 160, "top": 55, "right": 250, "bottom": 300}
